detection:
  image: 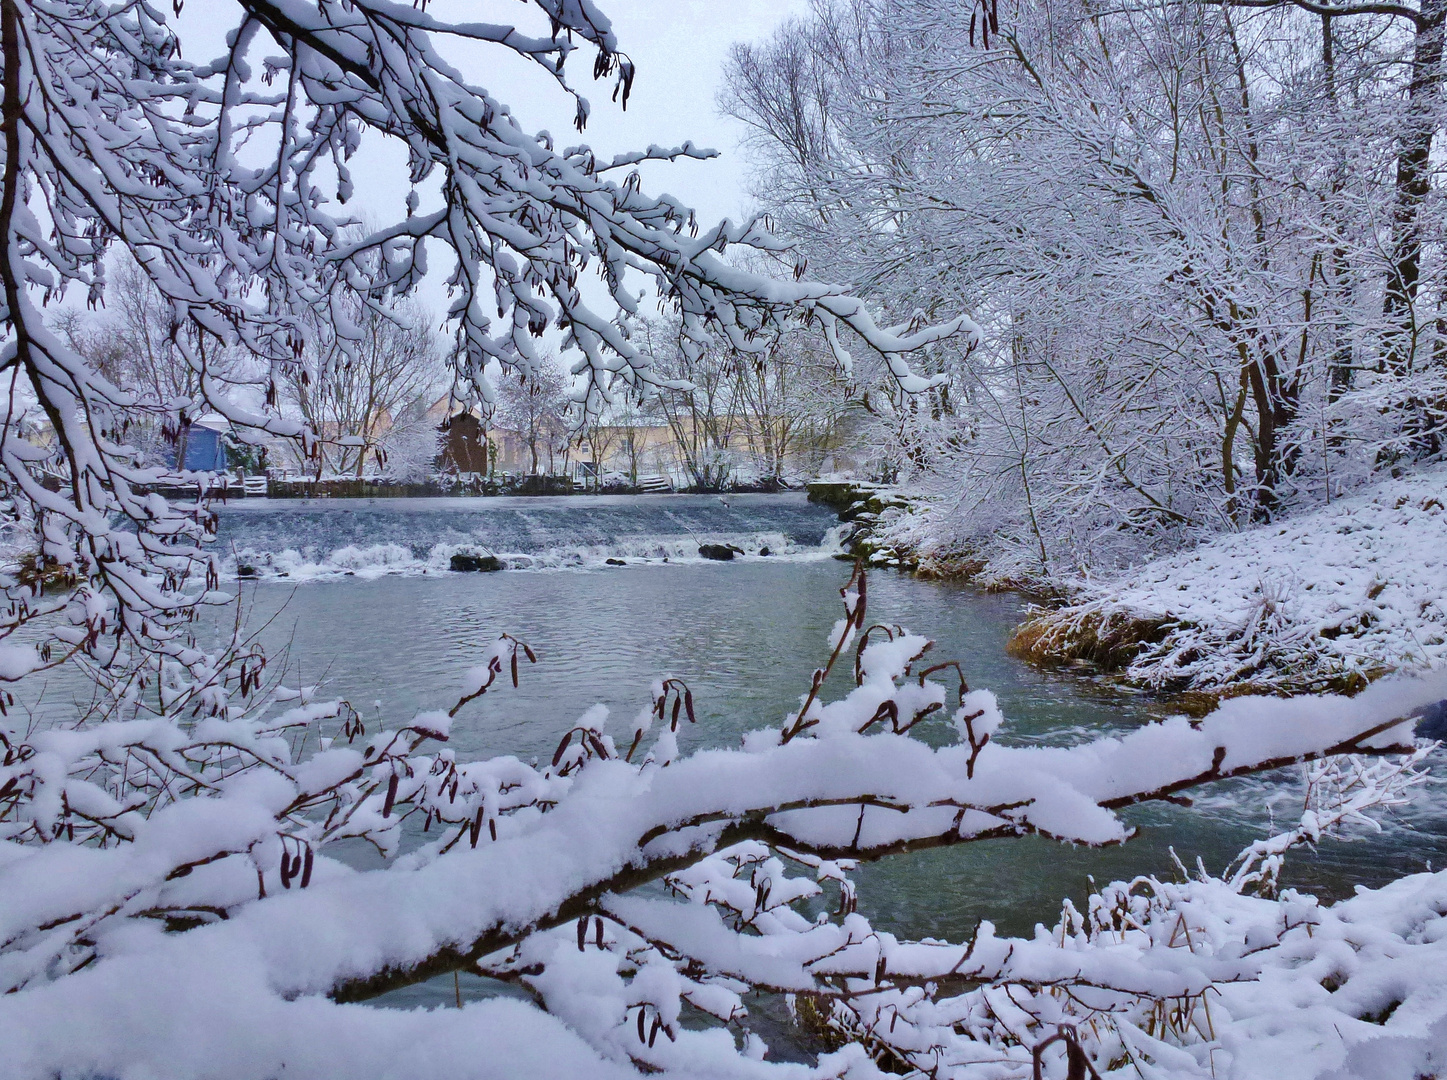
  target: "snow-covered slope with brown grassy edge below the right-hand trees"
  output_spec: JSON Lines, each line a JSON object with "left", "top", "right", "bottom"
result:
{"left": 1018, "top": 468, "right": 1447, "bottom": 688}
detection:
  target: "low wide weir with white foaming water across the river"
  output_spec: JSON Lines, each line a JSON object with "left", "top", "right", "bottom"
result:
{"left": 217, "top": 494, "right": 838, "bottom": 578}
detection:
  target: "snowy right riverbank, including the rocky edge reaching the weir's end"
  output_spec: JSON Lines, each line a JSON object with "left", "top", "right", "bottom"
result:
{"left": 821, "top": 466, "right": 1447, "bottom": 706}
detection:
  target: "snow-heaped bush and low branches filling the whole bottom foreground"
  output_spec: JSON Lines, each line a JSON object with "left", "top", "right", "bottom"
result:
{"left": 0, "top": 573, "right": 1447, "bottom": 1080}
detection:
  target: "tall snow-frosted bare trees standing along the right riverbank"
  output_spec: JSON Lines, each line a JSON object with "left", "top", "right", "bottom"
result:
{"left": 725, "top": 0, "right": 1447, "bottom": 576}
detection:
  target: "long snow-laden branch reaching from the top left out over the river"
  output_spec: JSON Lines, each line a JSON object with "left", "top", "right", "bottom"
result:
{"left": 245, "top": 0, "right": 978, "bottom": 402}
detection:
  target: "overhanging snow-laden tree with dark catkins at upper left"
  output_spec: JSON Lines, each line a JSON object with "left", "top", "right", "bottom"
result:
{"left": 0, "top": 0, "right": 972, "bottom": 675}
